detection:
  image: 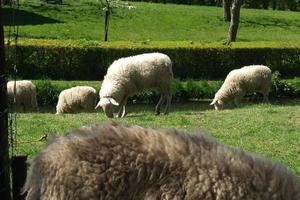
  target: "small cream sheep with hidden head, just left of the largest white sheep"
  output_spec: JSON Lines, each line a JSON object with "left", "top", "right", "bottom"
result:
{"left": 56, "top": 86, "right": 97, "bottom": 114}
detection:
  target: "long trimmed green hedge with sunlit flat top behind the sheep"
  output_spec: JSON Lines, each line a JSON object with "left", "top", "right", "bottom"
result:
{"left": 11, "top": 40, "right": 300, "bottom": 80}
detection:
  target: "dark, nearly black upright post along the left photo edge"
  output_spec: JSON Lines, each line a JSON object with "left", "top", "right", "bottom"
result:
{"left": 0, "top": 1, "right": 11, "bottom": 200}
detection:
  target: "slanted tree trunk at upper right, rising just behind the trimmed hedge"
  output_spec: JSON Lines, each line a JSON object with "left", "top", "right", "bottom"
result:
{"left": 228, "top": 0, "right": 243, "bottom": 43}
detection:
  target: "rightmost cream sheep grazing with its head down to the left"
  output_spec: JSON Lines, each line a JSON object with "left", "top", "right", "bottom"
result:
{"left": 210, "top": 65, "right": 272, "bottom": 110}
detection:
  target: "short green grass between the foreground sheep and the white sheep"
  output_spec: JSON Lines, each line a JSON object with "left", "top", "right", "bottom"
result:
{"left": 17, "top": 100, "right": 300, "bottom": 175}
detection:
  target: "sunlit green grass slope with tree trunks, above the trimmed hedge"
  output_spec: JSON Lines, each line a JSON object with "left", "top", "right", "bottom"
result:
{"left": 5, "top": 0, "right": 300, "bottom": 42}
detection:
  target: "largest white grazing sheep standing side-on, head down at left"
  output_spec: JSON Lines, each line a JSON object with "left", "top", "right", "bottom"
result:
{"left": 96, "top": 53, "right": 173, "bottom": 118}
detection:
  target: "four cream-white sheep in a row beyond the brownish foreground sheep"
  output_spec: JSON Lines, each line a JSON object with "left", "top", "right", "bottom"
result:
{"left": 7, "top": 53, "right": 272, "bottom": 118}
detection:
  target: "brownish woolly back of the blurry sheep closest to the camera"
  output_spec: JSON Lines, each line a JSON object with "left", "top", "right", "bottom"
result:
{"left": 24, "top": 123, "right": 300, "bottom": 200}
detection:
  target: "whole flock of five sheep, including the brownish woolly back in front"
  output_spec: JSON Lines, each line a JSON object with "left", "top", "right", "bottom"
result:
{"left": 8, "top": 53, "right": 300, "bottom": 200}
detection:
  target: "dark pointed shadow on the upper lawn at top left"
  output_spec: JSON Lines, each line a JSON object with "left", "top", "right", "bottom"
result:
{"left": 2, "top": 8, "right": 62, "bottom": 26}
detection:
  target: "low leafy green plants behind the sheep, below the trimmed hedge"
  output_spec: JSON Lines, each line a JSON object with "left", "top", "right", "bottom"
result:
{"left": 33, "top": 77, "right": 300, "bottom": 106}
